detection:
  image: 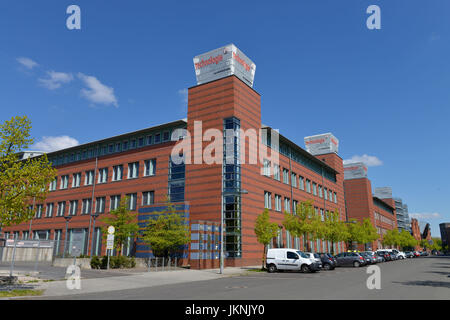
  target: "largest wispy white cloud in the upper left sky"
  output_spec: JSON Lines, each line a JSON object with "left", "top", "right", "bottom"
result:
{"left": 78, "top": 72, "right": 119, "bottom": 108}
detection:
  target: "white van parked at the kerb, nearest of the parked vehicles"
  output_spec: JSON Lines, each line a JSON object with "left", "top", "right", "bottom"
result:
{"left": 266, "top": 248, "right": 322, "bottom": 272}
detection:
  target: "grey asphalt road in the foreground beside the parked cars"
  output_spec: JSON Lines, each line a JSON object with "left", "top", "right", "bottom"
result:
{"left": 36, "top": 257, "right": 450, "bottom": 300}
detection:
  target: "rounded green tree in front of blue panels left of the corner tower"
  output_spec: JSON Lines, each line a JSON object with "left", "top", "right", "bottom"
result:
{"left": 142, "top": 199, "right": 190, "bottom": 257}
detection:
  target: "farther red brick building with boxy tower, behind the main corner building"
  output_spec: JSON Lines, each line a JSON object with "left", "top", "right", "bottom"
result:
{"left": 344, "top": 162, "right": 397, "bottom": 250}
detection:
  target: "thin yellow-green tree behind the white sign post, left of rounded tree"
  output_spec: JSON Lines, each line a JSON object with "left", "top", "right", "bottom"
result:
{"left": 100, "top": 197, "right": 139, "bottom": 255}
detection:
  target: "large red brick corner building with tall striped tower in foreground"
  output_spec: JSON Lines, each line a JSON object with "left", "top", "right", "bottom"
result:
{"left": 3, "top": 44, "right": 345, "bottom": 268}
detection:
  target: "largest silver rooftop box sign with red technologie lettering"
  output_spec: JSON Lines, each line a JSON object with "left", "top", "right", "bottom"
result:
{"left": 194, "top": 44, "right": 256, "bottom": 87}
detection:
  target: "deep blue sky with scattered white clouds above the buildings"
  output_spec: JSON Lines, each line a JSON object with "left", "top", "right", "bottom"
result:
{"left": 0, "top": 0, "right": 450, "bottom": 236}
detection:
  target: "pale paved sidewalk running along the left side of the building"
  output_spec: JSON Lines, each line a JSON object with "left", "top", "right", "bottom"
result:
{"left": 15, "top": 267, "right": 258, "bottom": 298}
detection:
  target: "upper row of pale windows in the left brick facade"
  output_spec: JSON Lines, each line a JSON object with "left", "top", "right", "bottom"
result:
{"left": 49, "top": 159, "right": 156, "bottom": 191}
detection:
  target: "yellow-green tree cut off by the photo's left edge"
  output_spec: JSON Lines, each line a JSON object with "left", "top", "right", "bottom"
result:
{"left": 0, "top": 116, "right": 56, "bottom": 228}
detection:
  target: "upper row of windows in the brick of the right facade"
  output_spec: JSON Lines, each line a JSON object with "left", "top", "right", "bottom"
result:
{"left": 263, "top": 160, "right": 337, "bottom": 203}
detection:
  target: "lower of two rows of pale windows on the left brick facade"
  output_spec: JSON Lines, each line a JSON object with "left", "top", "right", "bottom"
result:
{"left": 29, "top": 191, "right": 155, "bottom": 219}
